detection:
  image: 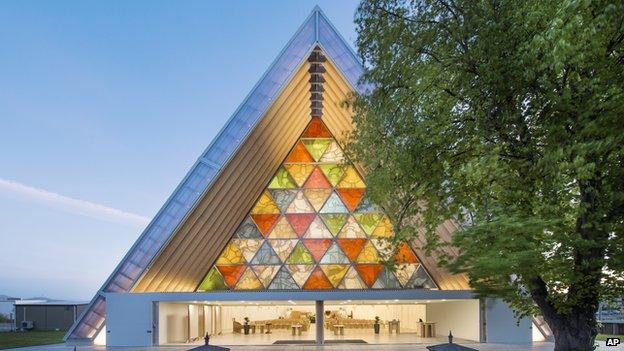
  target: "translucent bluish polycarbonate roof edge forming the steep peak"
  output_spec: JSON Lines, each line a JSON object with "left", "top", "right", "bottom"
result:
{"left": 65, "top": 6, "right": 364, "bottom": 340}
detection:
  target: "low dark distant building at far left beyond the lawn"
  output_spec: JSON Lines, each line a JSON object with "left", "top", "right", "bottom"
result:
{"left": 15, "top": 300, "right": 87, "bottom": 330}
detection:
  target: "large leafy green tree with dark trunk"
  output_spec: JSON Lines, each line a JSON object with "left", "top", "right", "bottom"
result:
{"left": 348, "top": 0, "right": 624, "bottom": 351}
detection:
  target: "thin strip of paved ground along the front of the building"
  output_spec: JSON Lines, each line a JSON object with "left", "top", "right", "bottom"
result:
{"left": 3, "top": 341, "right": 624, "bottom": 351}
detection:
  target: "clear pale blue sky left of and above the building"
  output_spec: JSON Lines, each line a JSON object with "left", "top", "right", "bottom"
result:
{"left": 0, "top": 0, "right": 357, "bottom": 300}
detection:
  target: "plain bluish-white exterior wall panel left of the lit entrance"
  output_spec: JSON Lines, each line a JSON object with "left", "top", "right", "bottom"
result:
{"left": 106, "top": 294, "right": 153, "bottom": 347}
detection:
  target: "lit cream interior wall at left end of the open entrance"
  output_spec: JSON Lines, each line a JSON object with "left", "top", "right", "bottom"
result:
{"left": 158, "top": 302, "right": 189, "bottom": 345}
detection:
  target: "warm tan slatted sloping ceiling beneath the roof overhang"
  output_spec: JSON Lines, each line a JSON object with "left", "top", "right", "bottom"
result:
{"left": 132, "top": 53, "right": 469, "bottom": 292}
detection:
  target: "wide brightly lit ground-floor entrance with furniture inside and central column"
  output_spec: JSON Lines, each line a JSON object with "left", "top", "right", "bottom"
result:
{"left": 158, "top": 300, "right": 479, "bottom": 346}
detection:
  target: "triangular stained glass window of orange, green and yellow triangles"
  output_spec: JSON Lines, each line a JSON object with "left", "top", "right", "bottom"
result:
{"left": 198, "top": 117, "right": 436, "bottom": 291}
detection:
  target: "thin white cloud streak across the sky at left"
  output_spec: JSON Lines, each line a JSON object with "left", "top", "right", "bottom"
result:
{"left": 0, "top": 178, "right": 150, "bottom": 227}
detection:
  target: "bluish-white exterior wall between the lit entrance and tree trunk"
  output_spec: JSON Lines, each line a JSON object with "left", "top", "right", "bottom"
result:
{"left": 485, "top": 299, "right": 533, "bottom": 344}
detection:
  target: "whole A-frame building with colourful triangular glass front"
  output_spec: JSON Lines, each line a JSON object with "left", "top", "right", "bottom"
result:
{"left": 65, "top": 7, "right": 532, "bottom": 346}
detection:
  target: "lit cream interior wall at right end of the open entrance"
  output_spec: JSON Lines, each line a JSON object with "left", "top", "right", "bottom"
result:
{"left": 423, "top": 300, "right": 479, "bottom": 341}
